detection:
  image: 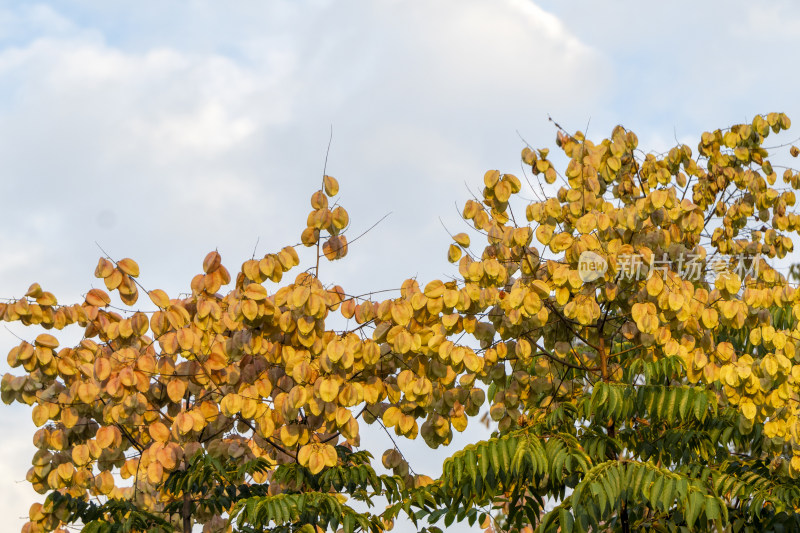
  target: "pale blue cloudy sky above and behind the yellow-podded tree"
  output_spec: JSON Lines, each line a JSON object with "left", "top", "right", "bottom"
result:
{"left": 0, "top": 0, "right": 800, "bottom": 531}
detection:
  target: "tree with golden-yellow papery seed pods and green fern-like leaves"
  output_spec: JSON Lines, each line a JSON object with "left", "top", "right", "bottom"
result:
{"left": 0, "top": 114, "right": 800, "bottom": 532}
